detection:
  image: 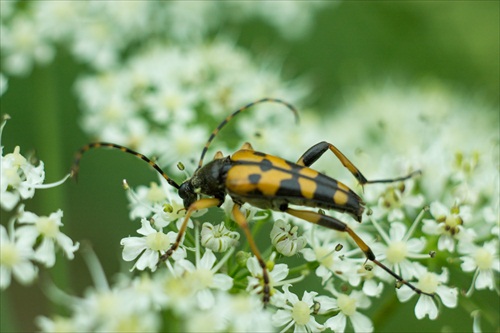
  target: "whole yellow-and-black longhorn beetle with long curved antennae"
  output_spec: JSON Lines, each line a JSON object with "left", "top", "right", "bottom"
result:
{"left": 72, "top": 98, "right": 434, "bottom": 304}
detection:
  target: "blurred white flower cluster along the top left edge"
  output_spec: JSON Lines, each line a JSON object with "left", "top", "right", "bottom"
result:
{"left": 0, "top": 0, "right": 325, "bottom": 75}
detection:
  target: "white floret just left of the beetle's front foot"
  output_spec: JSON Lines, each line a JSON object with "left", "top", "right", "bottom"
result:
{"left": 120, "top": 219, "right": 185, "bottom": 271}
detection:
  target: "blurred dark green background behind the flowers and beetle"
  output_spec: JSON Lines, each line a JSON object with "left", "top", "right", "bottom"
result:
{"left": 0, "top": 1, "right": 500, "bottom": 332}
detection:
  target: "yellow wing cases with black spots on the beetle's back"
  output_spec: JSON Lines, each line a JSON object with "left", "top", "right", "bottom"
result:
{"left": 225, "top": 150, "right": 364, "bottom": 221}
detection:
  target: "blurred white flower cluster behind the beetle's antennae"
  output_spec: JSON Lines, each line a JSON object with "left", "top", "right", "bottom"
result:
{"left": 76, "top": 41, "right": 307, "bottom": 169}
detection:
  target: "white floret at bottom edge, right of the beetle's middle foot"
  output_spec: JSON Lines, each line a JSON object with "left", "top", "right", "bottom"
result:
{"left": 271, "top": 284, "right": 324, "bottom": 332}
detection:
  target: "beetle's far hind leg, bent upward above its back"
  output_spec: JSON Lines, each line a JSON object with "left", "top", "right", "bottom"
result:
{"left": 297, "top": 141, "right": 421, "bottom": 186}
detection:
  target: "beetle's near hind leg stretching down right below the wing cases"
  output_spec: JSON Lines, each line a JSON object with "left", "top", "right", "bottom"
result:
{"left": 285, "top": 208, "right": 434, "bottom": 297}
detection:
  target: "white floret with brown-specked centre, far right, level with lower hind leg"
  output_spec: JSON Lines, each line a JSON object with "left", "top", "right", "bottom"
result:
{"left": 422, "top": 201, "right": 474, "bottom": 252}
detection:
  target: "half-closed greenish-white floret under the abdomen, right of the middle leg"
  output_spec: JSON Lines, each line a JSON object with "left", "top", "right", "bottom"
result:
{"left": 271, "top": 219, "right": 307, "bottom": 257}
